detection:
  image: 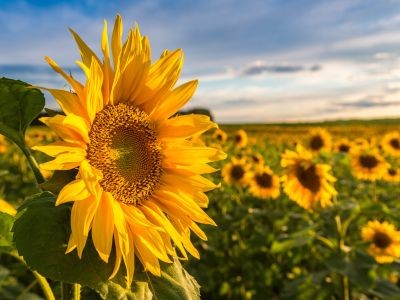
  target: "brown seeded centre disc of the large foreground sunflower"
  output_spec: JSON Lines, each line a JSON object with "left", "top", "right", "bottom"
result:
{"left": 87, "top": 103, "right": 162, "bottom": 204}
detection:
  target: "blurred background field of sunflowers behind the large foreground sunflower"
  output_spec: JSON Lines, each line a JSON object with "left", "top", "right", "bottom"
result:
{"left": 0, "top": 120, "right": 400, "bottom": 299}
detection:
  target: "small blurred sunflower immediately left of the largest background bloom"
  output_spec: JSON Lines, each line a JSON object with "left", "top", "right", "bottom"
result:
{"left": 249, "top": 166, "right": 280, "bottom": 199}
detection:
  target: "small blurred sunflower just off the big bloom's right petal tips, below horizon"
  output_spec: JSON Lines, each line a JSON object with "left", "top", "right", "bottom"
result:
{"left": 222, "top": 157, "right": 250, "bottom": 186}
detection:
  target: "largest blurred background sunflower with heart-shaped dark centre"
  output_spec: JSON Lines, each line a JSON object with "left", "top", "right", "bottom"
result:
{"left": 281, "top": 145, "right": 337, "bottom": 210}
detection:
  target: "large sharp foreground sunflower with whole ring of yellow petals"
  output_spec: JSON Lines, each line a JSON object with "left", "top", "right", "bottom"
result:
{"left": 34, "top": 16, "right": 226, "bottom": 284}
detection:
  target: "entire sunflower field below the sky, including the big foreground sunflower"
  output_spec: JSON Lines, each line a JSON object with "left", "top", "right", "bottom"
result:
{"left": 0, "top": 15, "right": 400, "bottom": 300}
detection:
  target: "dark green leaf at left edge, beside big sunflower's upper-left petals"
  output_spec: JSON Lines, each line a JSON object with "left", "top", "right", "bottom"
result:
{"left": 0, "top": 77, "right": 45, "bottom": 148}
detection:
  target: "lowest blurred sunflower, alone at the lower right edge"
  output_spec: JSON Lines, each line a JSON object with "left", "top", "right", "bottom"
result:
{"left": 361, "top": 220, "right": 400, "bottom": 264}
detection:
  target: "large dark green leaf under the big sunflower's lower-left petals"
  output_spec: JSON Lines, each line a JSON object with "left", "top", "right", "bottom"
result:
{"left": 13, "top": 192, "right": 113, "bottom": 289}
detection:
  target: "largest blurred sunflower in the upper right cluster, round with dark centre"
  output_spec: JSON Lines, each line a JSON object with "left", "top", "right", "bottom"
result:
{"left": 351, "top": 148, "right": 389, "bottom": 181}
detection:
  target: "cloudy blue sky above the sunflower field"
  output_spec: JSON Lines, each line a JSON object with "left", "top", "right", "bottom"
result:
{"left": 0, "top": 0, "right": 400, "bottom": 123}
